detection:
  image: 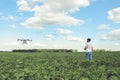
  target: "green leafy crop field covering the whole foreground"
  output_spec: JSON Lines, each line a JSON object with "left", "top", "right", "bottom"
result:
{"left": 0, "top": 51, "right": 120, "bottom": 80}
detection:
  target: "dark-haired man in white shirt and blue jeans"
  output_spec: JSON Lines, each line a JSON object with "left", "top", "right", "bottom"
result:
{"left": 84, "top": 38, "right": 93, "bottom": 61}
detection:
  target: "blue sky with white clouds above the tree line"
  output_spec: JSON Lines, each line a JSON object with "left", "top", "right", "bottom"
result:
{"left": 0, "top": 0, "right": 120, "bottom": 51}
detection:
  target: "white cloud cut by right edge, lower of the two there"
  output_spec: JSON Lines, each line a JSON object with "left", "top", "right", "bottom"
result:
{"left": 101, "top": 29, "right": 120, "bottom": 40}
